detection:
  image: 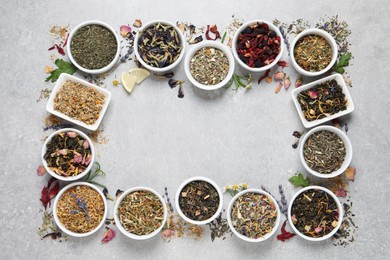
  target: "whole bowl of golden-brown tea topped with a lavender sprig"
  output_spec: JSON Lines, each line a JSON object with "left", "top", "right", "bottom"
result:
{"left": 53, "top": 182, "right": 108, "bottom": 237}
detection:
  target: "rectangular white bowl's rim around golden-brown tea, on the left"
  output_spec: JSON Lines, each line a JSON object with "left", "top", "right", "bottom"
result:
{"left": 46, "top": 73, "right": 111, "bottom": 131}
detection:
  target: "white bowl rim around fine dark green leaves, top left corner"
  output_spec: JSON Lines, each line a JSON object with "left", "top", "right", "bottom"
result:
{"left": 66, "top": 20, "right": 121, "bottom": 74}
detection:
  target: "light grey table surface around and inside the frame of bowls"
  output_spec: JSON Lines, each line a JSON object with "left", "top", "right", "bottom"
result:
{"left": 0, "top": 0, "right": 390, "bottom": 259}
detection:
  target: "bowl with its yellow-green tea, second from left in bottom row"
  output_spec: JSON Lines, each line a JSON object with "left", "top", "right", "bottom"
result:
{"left": 114, "top": 187, "right": 168, "bottom": 240}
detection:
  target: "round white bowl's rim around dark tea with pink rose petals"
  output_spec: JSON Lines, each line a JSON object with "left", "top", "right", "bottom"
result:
{"left": 42, "top": 128, "right": 95, "bottom": 181}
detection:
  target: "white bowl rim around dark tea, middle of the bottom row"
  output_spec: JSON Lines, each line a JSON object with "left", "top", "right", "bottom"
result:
{"left": 175, "top": 176, "right": 223, "bottom": 225}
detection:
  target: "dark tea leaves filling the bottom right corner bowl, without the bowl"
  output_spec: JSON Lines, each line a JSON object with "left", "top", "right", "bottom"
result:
{"left": 291, "top": 189, "right": 339, "bottom": 238}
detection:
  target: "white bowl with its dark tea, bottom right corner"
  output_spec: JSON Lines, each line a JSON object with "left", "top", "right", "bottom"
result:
{"left": 287, "top": 186, "right": 343, "bottom": 241}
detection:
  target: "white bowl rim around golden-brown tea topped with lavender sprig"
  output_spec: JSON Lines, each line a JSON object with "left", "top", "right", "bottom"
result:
{"left": 53, "top": 182, "right": 108, "bottom": 237}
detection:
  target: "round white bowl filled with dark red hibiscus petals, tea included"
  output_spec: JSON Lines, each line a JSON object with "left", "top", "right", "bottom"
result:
{"left": 232, "top": 20, "right": 284, "bottom": 72}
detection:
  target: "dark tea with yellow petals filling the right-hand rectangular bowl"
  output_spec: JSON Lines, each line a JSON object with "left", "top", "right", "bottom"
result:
{"left": 297, "top": 80, "right": 348, "bottom": 122}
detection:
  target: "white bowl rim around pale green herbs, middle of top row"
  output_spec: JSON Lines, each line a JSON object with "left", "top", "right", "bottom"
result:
{"left": 184, "top": 41, "right": 234, "bottom": 90}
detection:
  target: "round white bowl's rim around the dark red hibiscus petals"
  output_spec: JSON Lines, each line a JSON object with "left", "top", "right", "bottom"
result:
{"left": 232, "top": 20, "right": 284, "bottom": 72}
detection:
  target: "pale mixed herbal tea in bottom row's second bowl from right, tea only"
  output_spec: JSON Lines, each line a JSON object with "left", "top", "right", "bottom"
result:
{"left": 231, "top": 192, "right": 278, "bottom": 239}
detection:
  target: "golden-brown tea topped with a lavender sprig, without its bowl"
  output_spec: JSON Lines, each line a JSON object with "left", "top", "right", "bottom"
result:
{"left": 57, "top": 185, "right": 105, "bottom": 233}
